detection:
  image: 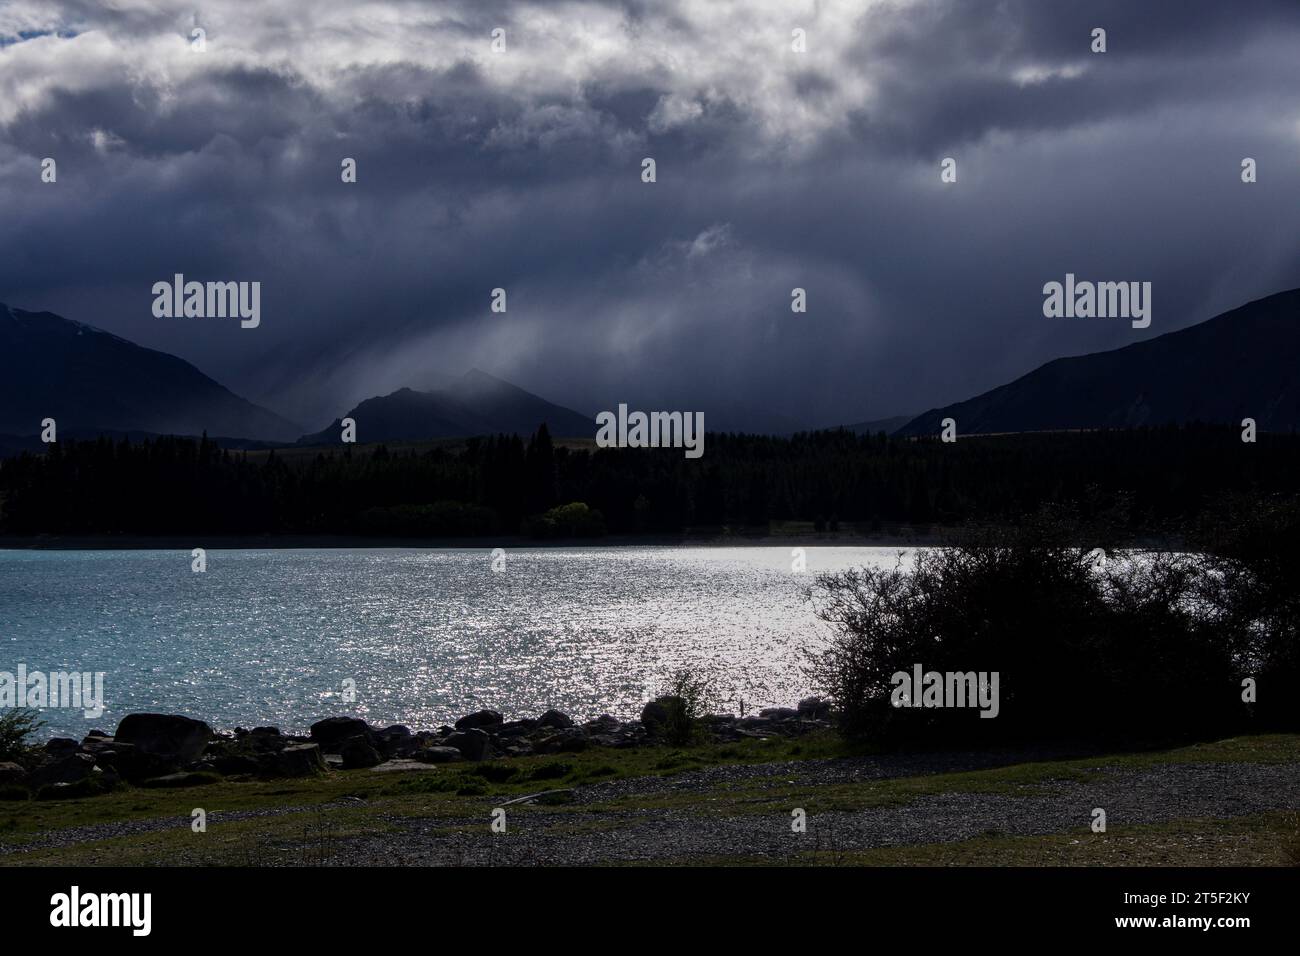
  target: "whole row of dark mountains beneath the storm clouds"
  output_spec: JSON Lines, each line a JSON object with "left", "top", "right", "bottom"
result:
{"left": 0, "top": 289, "right": 1300, "bottom": 455}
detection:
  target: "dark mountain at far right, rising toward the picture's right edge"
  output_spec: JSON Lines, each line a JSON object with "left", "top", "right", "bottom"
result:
{"left": 898, "top": 289, "right": 1300, "bottom": 436}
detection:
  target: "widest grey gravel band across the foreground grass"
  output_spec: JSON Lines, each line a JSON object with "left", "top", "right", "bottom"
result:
{"left": 332, "top": 763, "right": 1300, "bottom": 866}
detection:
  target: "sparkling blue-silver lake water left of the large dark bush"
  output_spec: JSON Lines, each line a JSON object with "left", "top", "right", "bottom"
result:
{"left": 0, "top": 546, "right": 906, "bottom": 736}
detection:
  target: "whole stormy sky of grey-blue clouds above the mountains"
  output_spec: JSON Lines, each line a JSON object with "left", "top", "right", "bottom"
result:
{"left": 0, "top": 0, "right": 1300, "bottom": 428}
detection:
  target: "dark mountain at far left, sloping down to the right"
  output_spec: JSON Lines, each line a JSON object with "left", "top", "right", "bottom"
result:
{"left": 0, "top": 303, "right": 303, "bottom": 441}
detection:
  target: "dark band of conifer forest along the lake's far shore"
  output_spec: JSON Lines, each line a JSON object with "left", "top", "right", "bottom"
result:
{"left": 0, "top": 425, "right": 1300, "bottom": 538}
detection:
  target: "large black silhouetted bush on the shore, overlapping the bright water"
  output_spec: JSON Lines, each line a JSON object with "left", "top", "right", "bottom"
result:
{"left": 810, "top": 514, "right": 1247, "bottom": 744}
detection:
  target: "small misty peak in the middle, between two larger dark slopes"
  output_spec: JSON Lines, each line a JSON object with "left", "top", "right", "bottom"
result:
{"left": 298, "top": 368, "right": 595, "bottom": 445}
